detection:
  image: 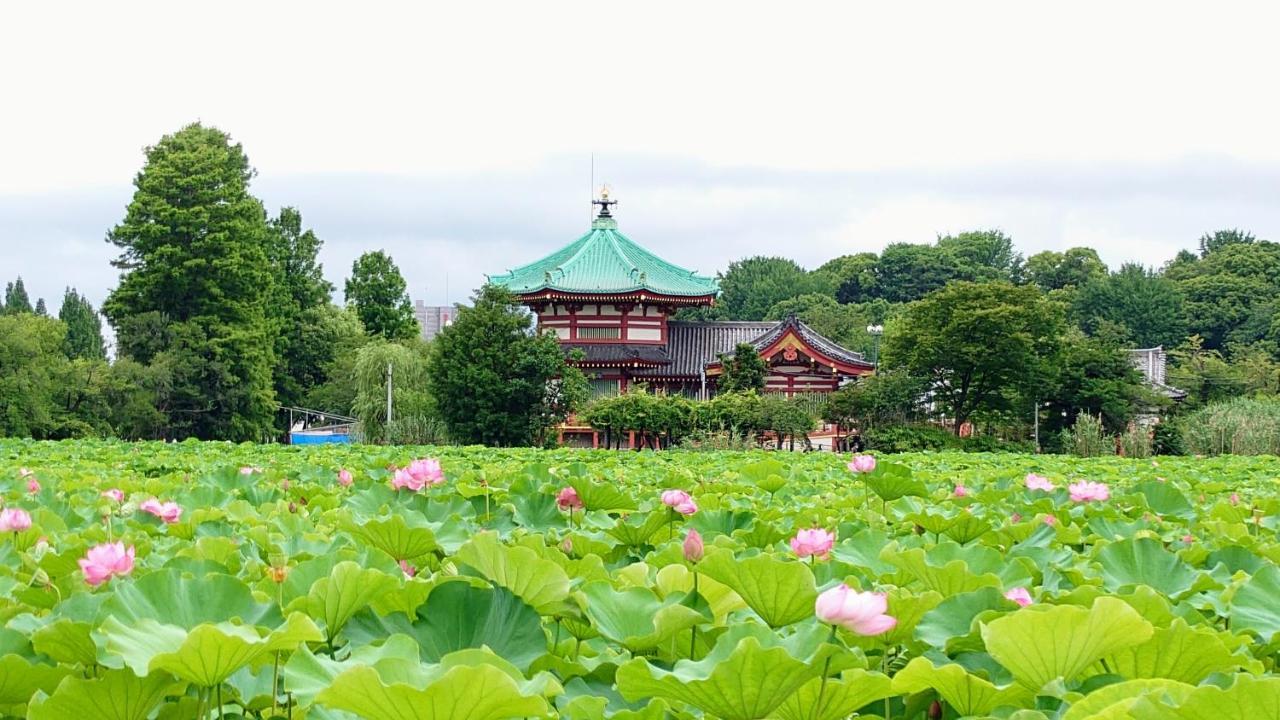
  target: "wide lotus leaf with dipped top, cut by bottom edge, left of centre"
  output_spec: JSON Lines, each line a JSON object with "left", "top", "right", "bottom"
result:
{"left": 316, "top": 665, "right": 549, "bottom": 720}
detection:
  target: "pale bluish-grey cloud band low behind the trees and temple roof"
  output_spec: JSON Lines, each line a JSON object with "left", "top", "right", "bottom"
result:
{"left": 0, "top": 155, "right": 1280, "bottom": 316}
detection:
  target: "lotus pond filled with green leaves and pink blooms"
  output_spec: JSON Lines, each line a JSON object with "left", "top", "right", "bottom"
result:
{"left": 0, "top": 441, "right": 1280, "bottom": 720}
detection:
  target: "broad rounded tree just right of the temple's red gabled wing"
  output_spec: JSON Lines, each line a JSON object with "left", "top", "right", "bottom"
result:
{"left": 883, "top": 282, "right": 1062, "bottom": 432}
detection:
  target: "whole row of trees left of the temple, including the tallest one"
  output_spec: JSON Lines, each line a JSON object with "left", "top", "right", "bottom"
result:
{"left": 0, "top": 123, "right": 585, "bottom": 445}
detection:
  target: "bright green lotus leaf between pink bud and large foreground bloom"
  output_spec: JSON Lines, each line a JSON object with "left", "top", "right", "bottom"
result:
{"left": 698, "top": 548, "right": 818, "bottom": 628}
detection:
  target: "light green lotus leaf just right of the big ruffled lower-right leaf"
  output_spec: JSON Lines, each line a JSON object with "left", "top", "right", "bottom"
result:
{"left": 1103, "top": 618, "right": 1242, "bottom": 685}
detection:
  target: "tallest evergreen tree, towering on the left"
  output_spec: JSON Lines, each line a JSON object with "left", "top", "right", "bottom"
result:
{"left": 102, "top": 123, "right": 275, "bottom": 439}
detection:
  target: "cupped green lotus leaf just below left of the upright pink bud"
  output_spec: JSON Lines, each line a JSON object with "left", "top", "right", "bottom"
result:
{"left": 581, "top": 580, "right": 704, "bottom": 651}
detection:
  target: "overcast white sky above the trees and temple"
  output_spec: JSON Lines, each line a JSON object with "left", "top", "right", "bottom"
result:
{"left": 0, "top": 1, "right": 1280, "bottom": 313}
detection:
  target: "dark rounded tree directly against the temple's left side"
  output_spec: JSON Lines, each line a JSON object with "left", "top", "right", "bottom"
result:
{"left": 428, "top": 284, "right": 586, "bottom": 446}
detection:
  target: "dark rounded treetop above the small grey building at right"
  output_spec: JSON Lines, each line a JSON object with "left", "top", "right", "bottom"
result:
{"left": 1071, "top": 263, "right": 1187, "bottom": 347}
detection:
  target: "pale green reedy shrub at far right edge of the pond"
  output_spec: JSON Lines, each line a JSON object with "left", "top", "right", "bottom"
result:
{"left": 1183, "top": 397, "right": 1280, "bottom": 455}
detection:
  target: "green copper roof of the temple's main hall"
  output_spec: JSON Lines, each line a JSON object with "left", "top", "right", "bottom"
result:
{"left": 489, "top": 213, "right": 719, "bottom": 297}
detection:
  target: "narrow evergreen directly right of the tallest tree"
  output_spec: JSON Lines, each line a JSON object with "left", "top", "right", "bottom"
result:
{"left": 269, "top": 208, "right": 334, "bottom": 405}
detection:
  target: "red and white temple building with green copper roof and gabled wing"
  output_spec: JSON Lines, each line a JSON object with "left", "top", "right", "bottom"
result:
{"left": 489, "top": 190, "right": 873, "bottom": 398}
